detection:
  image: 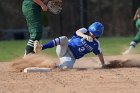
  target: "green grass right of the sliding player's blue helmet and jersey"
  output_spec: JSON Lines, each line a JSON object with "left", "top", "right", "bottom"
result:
{"left": 100, "top": 37, "right": 140, "bottom": 55}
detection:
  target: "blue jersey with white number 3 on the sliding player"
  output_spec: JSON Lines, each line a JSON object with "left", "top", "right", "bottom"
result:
{"left": 68, "top": 28, "right": 101, "bottom": 59}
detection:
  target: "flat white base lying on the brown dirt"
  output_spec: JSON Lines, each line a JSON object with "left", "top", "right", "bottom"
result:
{"left": 23, "top": 67, "right": 52, "bottom": 73}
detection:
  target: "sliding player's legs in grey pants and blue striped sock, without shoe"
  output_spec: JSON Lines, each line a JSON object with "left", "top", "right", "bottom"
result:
{"left": 33, "top": 36, "right": 75, "bottom": 69}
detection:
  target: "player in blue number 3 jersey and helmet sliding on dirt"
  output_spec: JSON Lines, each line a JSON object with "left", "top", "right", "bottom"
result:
{"left": 35, "top": 22, "right": 105, "bottom": 69}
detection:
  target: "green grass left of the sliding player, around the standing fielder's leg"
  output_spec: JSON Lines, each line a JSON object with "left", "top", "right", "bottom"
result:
{"left": 0, "top": 40, "right": 56, "bottom": 61}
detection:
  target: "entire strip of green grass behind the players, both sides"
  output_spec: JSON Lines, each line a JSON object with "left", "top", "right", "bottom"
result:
{"left": 0, "top": 37, "right": 140, "bottom": 61}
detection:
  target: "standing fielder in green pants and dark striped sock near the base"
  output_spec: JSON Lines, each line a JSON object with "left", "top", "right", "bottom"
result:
{"left": 22, "top": 0, "right": 48, "bottom": 55}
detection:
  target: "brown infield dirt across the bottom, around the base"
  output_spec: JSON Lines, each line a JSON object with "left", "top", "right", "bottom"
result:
{"left": 0, "top": 55, "right": 140, "bottom": 93}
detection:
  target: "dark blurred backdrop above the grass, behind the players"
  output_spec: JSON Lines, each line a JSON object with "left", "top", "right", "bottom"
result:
{"left": 0, "top": 0, "right": 140, "bottom": 37}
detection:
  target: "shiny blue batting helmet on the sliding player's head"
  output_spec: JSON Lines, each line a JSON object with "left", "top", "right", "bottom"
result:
{"left": 88, "top": 22, "right": 104, "bottom": 37}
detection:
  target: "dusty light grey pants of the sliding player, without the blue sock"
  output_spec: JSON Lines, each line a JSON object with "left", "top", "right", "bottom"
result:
{"left": 56, "top": 36, "right": 75, "bottom": 69}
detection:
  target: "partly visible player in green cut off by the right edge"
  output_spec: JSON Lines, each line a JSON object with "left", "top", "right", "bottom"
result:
{"left": 123, "top": 8, "right": 140, "bottom": 54}
